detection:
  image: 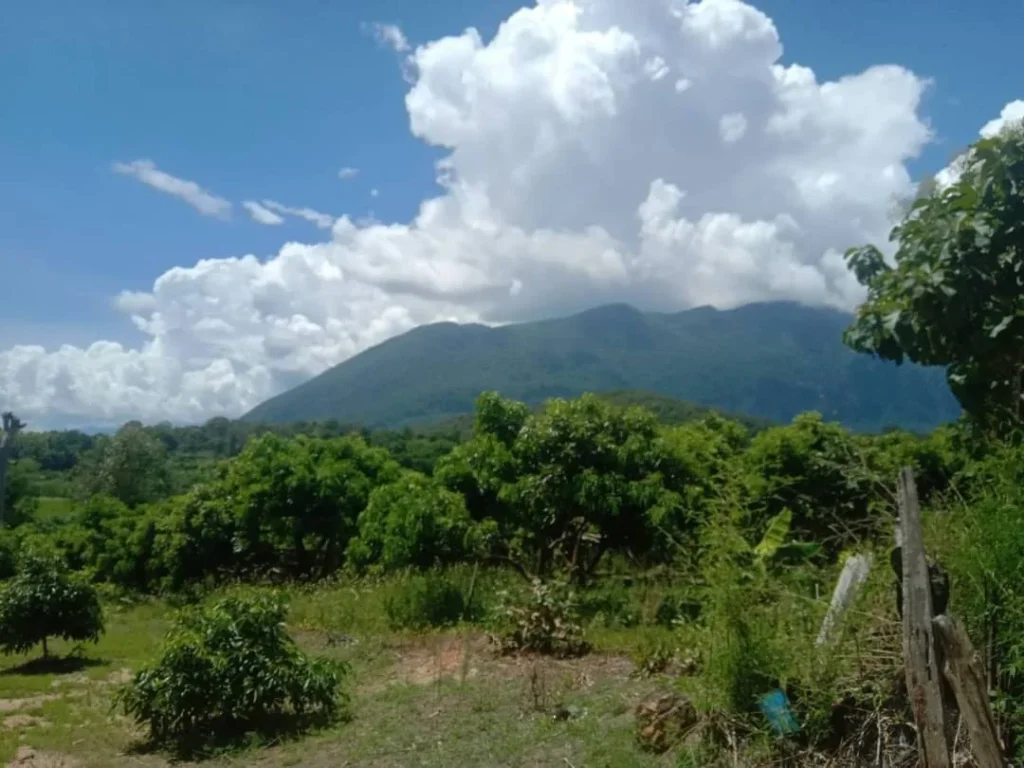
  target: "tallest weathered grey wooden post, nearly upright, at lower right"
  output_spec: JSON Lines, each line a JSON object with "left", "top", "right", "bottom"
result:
{"left": 898, "top": 467, "right": 951, "bottom": 768}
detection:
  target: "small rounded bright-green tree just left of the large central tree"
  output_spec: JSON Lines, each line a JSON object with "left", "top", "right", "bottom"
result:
{"left": 347, "top": 471, "right": 473, "bottom": 570}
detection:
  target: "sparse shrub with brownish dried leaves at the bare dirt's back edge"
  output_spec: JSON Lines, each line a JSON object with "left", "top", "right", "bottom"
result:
{"left": 501, "top": 579, "right": 590, "bottom": 656}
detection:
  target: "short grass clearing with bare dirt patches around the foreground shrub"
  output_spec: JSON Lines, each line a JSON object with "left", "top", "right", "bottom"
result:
{"left": 0, "top": 586, "right": 678, "bottom": 768}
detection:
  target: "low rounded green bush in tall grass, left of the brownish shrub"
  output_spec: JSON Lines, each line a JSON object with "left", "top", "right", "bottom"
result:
{"left": 384, "top": 570, "right": 482, "bottom": 630}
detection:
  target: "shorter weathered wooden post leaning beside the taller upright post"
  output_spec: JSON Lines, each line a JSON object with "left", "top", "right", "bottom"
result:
{"left": 932, "top": 615, "right": 1007, "bottom": 768}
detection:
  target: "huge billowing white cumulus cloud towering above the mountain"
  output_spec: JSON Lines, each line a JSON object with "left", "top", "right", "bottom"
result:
{"left": 6, "top": 0, "right": 1015, "bottom": 434}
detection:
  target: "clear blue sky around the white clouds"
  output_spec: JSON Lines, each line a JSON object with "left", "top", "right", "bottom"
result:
{"left": 0, "top": 0, "right": 1024, "bottom": 428}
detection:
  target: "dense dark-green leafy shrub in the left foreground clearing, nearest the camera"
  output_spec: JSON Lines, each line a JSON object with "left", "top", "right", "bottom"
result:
{"left": 115, "top": 596, "right": 346, "bottom": 753}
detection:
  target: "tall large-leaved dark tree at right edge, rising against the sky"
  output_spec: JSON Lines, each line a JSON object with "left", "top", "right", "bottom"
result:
{"left": 845, "top": 120, "right": 1024, "bottom": 431}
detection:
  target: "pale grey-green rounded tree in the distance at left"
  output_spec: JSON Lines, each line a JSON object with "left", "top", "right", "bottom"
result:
{"left": 79, "top": 422, "right": 170, "bottom": 507}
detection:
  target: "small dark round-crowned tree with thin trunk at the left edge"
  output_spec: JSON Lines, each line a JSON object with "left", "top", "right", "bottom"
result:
{"left": 0, "top": 557, "right": 103, "bottom": 657}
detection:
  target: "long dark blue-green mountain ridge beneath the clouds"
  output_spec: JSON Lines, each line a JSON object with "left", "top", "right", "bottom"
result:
{"left": 244, "top": 302, "right": 959, "bottom": 431}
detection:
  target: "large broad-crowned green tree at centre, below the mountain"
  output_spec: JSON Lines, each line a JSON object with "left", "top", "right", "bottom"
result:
{"left": 437, "top": 394, "right": 681, "bottom": 580}
